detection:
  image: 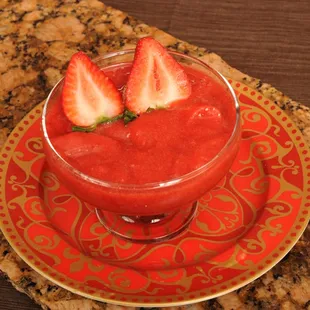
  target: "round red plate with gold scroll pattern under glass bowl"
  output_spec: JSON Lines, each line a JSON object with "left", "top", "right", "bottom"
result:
{"left": 0, "top": 82, "right": 310, "bottom": 306}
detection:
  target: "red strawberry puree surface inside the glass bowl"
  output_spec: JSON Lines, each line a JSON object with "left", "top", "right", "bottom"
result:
{"left": 47, "top": 64, "right": 235, "bottom": 184}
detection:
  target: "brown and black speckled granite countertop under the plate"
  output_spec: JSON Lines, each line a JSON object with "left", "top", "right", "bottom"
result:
{"left": 0, "top": 0, "right": 310, "bottom": 309}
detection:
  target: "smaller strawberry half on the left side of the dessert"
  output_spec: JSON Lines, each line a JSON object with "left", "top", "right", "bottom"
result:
{"left": 62, "top": 52, "right": 124, "bottom": 127}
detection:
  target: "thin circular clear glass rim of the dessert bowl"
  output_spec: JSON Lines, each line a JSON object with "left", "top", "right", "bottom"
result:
{"left": 41, "top": 49, "right": 240, "bottom": 190}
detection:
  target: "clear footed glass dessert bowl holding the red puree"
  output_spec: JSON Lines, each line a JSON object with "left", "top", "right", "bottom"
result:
{"left": 42, "top": 50, "right": 241, "bottom": 243}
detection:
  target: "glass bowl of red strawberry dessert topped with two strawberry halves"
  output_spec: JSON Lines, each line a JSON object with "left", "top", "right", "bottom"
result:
{"left": 42, "top": 38, "right": 240, "bottom": 242}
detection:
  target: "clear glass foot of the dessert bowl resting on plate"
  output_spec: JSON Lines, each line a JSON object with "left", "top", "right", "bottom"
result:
{"left": 96, "top": 202, "right": 197, "bottom": 244}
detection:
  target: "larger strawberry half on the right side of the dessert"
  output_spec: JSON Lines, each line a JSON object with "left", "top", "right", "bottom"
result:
{"left": 125, "top": 37, "right": 191, "bottom": 114}
